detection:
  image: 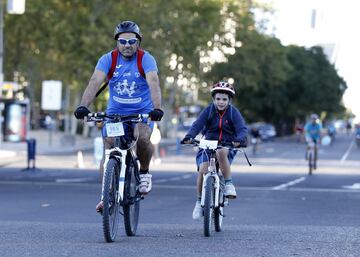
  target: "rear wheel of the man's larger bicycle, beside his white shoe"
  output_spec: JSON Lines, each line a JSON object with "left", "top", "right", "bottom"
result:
{"left": 123, "top": 154, "right": 141, "bottom": 236}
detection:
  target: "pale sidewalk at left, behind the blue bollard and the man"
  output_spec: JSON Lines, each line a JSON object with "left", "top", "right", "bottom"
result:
{"left": 0, "top": 130, "right": 176, "bottom": 170}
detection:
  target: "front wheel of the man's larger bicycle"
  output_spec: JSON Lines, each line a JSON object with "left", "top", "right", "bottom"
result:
{"left": 102, "top": 159, "right": 120, "bottom": 243}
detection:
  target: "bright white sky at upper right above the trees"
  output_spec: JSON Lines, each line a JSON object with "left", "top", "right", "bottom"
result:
{"left": 260, "top": 0, "right": 360, "bottom": 122}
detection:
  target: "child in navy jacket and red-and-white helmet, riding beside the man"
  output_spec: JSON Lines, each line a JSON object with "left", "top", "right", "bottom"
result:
{"left": 182, "top": 81, "right": 248, "bottom": 219}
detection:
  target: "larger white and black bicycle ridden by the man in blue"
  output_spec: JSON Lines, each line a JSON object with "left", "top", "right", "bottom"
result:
{"left": 87, "top": 112, "right": 149, "bottom": 242}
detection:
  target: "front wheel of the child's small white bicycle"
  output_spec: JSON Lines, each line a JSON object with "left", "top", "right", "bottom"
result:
{"left": 204, "top": 176, "right": 214, "bottom": 237}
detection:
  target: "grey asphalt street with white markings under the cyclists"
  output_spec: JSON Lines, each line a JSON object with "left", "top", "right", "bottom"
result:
{"left": 0, "top": 132, "right": 360, "bottom": 257}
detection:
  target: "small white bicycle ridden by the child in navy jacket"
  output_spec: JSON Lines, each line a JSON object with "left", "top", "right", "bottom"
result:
{"left": 181, "top": 139, "right": 251, "bottom": 237}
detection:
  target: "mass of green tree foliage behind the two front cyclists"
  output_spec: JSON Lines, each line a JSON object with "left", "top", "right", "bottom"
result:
{"left": 4, "top": 0, "right": 346, "bottom": 132}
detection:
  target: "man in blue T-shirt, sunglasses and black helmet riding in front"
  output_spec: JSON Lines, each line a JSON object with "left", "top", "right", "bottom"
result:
{"left": 74, "top": 21, "right": 164, "bottom": 212}
